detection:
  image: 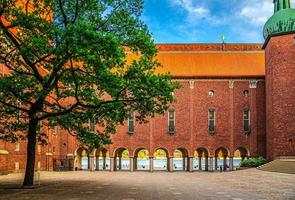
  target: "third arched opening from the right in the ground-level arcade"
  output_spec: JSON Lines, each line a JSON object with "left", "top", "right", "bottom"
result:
{"left": 193, "top": 147, "right": 209, "bottom": 171}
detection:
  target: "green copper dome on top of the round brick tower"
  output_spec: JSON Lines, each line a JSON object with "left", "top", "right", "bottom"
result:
{"left": 263, "top": 0, "right": 295, "bottom": 39}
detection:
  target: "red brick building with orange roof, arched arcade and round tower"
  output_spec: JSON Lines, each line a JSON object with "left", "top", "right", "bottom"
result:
{"left": 0, "top": 1, "right": 295, "bottom": 173}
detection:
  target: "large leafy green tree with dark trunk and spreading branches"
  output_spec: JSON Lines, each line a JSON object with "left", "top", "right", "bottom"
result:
{"left": 0, "top": 0, "right": 178, "bottom": 186}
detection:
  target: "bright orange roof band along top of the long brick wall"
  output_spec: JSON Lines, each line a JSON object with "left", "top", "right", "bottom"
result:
{"left": 128, "top": 44, "right": 265, "bottom": 78}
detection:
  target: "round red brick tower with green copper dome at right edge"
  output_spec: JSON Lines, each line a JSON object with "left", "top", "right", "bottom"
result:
{"left": 263, "top": 0, "right": 295, "bottom": 160}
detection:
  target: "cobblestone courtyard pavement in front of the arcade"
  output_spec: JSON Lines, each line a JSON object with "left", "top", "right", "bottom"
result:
{"left": 0, "top": 169, "right": 295, "bottom": 200}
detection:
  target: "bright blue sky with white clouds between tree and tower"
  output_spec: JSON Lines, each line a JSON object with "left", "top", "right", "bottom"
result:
{"left": 142, "top": 0, "right": 295, "bottom": 43}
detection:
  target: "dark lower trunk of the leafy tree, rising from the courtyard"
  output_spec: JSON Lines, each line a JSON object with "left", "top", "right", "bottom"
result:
{"left": 23, "top": 119, "right": 38, "bottom": 186}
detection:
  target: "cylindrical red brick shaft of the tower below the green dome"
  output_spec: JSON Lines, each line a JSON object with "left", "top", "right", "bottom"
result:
{"left": 265, "top": 34, "right": 295, "bottom": 159}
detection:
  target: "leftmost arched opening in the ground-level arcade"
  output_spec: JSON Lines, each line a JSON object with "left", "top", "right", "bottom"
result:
{"left": 74, "top": 147, "right": 90, "bottom": 170}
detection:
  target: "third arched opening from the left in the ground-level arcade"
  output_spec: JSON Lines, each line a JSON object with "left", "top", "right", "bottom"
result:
{"left": 114, "top": 148, "right": 130, "bottom": 171}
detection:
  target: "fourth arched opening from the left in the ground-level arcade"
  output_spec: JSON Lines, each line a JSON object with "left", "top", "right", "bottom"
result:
{"left": 134, "top": 148, "right": 150, "bottom": 171}
